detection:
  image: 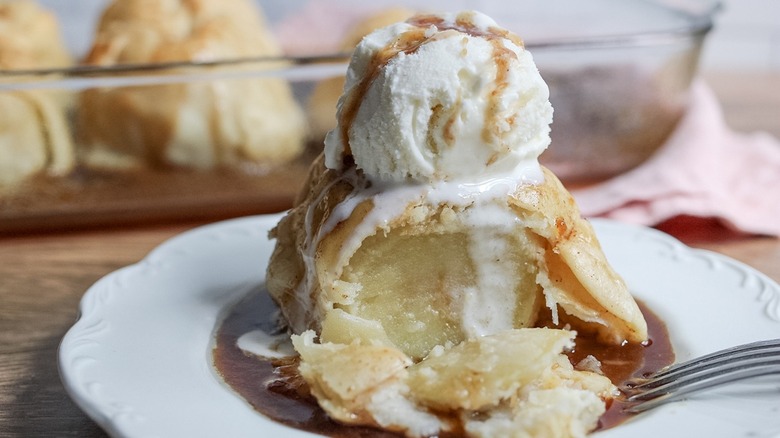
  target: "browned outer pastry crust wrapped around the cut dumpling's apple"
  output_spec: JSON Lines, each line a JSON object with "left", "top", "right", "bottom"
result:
{"left": 267, "top": 159, "right": 647, "bottom": 353}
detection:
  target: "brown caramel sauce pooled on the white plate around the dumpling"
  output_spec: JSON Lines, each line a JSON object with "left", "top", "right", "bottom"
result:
{"left": 213, "top": 289, "right": 674, "bottom": 438}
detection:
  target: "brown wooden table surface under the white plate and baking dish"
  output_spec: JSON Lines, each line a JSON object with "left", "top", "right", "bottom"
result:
{"left": 0, "top": 74, "right": 780, "bottom": 437}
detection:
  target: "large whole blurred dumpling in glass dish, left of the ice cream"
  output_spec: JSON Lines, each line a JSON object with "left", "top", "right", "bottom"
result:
{"left": 78, "top": 0, "right": 305, "bottom": 169}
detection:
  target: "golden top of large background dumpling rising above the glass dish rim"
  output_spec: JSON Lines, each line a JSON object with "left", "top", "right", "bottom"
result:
{"left": 85, "top": 0, "right": 281, "bottom": 65}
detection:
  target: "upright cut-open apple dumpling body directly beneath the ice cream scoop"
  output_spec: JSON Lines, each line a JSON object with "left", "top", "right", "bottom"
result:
{"left": 268, "top": 156, "right": 647, "bottom": 359}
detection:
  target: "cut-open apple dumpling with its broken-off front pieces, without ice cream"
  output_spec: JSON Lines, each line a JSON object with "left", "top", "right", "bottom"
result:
{"left": 266, "top": 157, "right": 647, "bottom": 437}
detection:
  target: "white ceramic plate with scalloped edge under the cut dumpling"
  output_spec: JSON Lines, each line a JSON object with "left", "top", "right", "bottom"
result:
{"left": 59, "top": 215, "right": 780, "bottom": 438}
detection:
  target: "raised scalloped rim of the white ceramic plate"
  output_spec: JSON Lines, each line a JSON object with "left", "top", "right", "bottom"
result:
{"left": 58, "top": 213, "right": 780, "bottom": 437}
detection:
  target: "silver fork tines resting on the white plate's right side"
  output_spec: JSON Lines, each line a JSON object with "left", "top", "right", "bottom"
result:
{"left": 620, "top": 339, "right": 780, "bottom": 413}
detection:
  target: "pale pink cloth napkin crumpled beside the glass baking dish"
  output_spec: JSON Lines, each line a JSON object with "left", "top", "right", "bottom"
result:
{"left": 572, "top": 80, "right": 780, "bottom": 236}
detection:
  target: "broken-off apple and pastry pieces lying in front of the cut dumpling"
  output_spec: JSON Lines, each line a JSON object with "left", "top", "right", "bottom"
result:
{"left": 293, "top": 328, "right": 615, "bottom": 438}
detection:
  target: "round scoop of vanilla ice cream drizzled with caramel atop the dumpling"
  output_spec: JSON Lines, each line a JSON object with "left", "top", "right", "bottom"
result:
{"left": 325, "top": 11, "right": 553, "bottom": 182}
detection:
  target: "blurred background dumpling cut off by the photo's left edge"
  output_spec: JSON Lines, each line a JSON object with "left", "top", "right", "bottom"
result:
{"left": 0, "top": 0, "right": 75, "bottom": 191}
